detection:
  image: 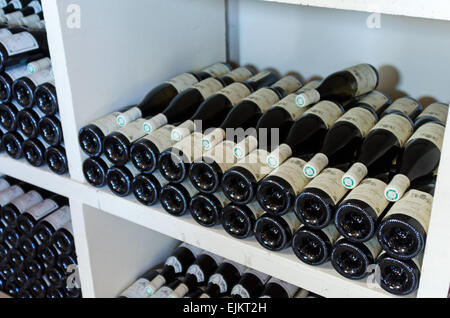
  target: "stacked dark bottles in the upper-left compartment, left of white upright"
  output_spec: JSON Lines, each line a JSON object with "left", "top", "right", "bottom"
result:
{"left": 0, "top": 5, "right": 68, "bottom": 174}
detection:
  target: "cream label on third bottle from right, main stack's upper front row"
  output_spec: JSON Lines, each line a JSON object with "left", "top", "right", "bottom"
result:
{"left": 307, "top": 168, "right": 348, "bottom": 205}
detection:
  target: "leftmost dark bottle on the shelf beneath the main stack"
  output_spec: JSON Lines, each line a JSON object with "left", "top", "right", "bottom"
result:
{"left": 145, "top": 243, "right": 202, "bottom": 296}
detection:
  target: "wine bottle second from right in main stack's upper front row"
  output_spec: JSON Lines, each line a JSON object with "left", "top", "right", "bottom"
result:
{"left": 335, "top": 178, "right": 389, "bottom": 243}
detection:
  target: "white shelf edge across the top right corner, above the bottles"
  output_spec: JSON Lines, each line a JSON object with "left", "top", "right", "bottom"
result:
{"left": 263, "top": 0, "right": 450, "bottom": 21}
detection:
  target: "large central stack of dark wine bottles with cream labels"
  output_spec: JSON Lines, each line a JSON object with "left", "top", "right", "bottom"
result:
{"left": 79, "top": 63, "right": 448, "bottom": 295}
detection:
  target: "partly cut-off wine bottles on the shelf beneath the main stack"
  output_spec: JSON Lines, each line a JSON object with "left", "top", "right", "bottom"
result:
{"left": 120, "top": 244, "right": 315, "bottom": 298}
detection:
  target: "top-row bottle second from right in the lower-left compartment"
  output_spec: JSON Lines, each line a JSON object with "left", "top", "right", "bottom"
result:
{"left": 17, "top": 194, "right": 69, "bottom": 235}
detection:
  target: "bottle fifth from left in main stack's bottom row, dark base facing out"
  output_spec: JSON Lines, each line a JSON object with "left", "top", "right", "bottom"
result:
{"left": 189, "top": 191, "right": 230, "bottom": 227}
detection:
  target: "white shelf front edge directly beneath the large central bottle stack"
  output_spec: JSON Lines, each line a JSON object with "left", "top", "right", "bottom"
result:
{"left": 91, "top": 189, "right": 415, "bottom": 298}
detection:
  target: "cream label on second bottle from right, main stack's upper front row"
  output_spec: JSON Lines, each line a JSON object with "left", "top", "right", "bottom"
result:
{"left": 345, "top": 179, "right": 389, "bottom": 216}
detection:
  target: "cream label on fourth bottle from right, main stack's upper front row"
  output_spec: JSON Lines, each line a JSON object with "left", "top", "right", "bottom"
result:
{"left": 270, "top": 158, "right": 311, "bottom": 196}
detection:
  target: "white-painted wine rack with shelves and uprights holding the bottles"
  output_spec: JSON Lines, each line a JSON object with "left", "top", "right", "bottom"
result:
{"left": 0, "top": 0, "right": 450, "bottom": 297}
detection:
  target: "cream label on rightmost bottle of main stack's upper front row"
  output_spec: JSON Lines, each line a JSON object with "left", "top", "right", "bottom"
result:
{"left": 386, "top": 190, "right": 433, "bottom": 231}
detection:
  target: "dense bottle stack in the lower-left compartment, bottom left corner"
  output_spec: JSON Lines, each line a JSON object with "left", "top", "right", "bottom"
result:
{"left": 0, "top": 176, "right": 81, "bottom": 298}
